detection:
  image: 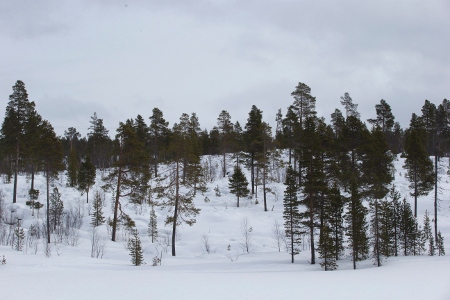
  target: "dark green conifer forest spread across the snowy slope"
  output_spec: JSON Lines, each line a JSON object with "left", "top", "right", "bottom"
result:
{"left": 0, "top": 80, "right": 450, "bottom": 271}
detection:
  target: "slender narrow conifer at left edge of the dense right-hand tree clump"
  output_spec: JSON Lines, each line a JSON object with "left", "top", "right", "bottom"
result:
{"left": 283, "top": 166, "right": 302, "bottom": 263}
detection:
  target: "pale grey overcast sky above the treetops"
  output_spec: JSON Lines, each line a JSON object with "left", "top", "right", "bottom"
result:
{"left": 0, "top": 0, "right": 450, "bottom": 135}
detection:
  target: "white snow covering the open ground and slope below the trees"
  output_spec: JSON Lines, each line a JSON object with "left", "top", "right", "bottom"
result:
{"left": 0, "top": 157, "right": 450, "bottom": 300}
